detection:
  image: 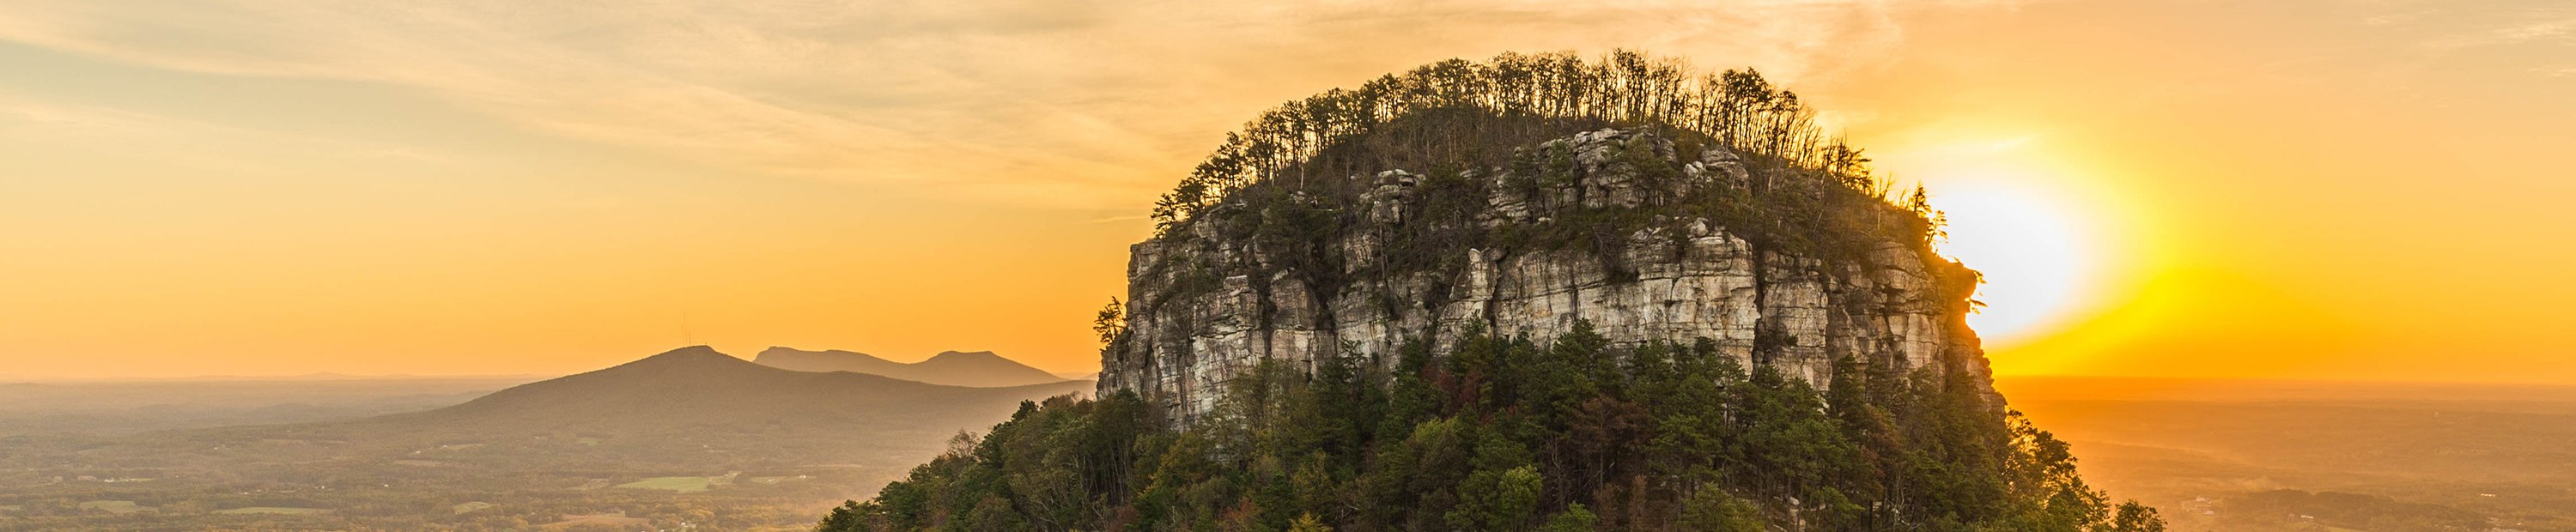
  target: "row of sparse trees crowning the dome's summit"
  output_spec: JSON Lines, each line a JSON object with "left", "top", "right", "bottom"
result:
{"left": 1151, "top": 49, "right": 1922, "bottom": 239}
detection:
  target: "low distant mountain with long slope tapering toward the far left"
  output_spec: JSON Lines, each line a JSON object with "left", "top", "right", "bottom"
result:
{"left": 63, "top": 347, "right": 1092, "bottom": 470}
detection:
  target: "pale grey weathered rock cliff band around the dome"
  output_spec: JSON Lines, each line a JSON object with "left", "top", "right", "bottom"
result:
{"left": 1100, "top": 129, "right": 1999, "bottom": 419}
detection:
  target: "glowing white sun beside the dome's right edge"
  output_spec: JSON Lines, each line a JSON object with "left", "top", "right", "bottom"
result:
{"left": 1932, "top": 180, "right": 2105, "bottom": 344}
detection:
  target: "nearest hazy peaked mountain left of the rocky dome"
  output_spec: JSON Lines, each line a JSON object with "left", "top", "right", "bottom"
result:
{"left": 345, "top": 347, "right": 1087, "bottom": 462}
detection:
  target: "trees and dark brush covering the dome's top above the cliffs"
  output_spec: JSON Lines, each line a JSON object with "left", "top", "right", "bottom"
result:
{"left": 1128, "top": 51, "right": 1976, "bottom": 326}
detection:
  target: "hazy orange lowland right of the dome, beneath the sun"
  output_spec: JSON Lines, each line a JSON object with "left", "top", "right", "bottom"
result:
{"left": 1996, "top": 378, "right": 2576, "bottom": 532}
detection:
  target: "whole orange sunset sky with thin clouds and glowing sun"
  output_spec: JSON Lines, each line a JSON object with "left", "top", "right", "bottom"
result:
{"left": 0, "top": 0, "right": 2576, "bottom": 383}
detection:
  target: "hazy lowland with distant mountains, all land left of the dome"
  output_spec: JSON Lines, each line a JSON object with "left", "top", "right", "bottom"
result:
{"left": 0, "top": 347, "right": 1092, "bottom": 529}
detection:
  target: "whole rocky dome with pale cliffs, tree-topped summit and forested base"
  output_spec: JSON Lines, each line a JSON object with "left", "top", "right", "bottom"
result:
{"left": 819, "top": 51, "right": 2164, "bottom": 532}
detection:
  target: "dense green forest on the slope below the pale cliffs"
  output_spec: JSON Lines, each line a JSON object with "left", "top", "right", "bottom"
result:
{"left": 819, "top": 323, "right": 2164, "bottom": 532}
